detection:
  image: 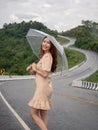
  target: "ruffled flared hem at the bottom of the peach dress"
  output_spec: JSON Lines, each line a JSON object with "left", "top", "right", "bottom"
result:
{"left": 28, "top": 100, "right": 52, "bottom": 110}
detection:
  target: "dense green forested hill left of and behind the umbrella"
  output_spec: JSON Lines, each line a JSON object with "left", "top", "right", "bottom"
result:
{"left": 0, "top": 21, "right": 58, "bottom": 75}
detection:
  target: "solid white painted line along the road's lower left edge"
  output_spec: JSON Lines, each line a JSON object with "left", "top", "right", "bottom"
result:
{"left": 0, "top": 92, "right": 31, "bottom": 130}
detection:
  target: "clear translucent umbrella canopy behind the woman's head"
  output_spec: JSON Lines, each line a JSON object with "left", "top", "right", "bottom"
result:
{"left": 26, "top": 29, "right": 68, "bottom": 72}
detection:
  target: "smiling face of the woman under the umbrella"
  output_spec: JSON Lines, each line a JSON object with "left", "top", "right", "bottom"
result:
{"left": 42, "top": 38, "right": 51, "bottom": 53}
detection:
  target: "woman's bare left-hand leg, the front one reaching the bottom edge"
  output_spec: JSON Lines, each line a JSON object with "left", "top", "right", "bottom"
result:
{"left": 30, "top": 108, "right": 48, "bottom": 130}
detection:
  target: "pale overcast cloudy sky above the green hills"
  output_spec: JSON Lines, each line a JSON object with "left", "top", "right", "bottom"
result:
{"left": 0, "top": 0, "right": 98, "bottom": 31}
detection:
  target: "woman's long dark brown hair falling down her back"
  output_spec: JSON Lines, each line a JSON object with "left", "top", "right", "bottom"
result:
{"left": 39, "top": 36, "right": 57, "bottom": 72}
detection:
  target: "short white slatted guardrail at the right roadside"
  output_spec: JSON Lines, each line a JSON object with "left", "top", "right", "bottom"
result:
{"left": 72, "top": 80, "right": 98, "bottom": 91}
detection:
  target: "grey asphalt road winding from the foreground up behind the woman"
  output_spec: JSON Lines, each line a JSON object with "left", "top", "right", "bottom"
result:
{"left": 0, "top": 36, "right": 98, "bottom": 130}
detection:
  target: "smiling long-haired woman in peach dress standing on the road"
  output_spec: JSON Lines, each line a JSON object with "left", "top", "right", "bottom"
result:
{"left": 29, "top": 37, "right": 57, "bottom": 130}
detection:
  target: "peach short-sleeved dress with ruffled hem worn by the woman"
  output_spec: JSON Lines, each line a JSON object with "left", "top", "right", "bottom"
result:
{"left": 28, "top": 53, "right": 53, "bottom": 110}
